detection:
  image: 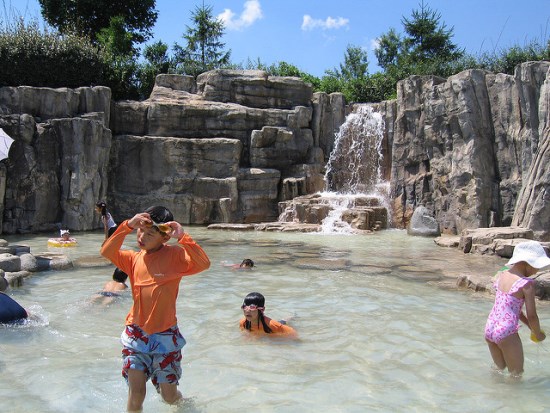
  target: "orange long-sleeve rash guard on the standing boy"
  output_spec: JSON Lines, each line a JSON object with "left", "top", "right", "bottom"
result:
{"left": 101, "top": 221, "right": 210, "bottom": 334}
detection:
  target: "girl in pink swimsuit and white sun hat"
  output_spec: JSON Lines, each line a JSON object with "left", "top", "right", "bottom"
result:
{"left": 485, "top": 241, "right": 550, "bottom": 376}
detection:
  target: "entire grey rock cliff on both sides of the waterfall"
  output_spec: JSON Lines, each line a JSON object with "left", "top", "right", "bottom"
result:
{"left": 0, "top": 62, "right": 550, "bottom": 240}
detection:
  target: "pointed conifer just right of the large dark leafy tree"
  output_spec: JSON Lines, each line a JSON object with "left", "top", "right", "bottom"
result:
{"left": 173, "top": 3, "right": 231, "bottom": 76}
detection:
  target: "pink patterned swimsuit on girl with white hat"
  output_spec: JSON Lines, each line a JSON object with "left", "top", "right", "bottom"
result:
{"left": 485, "top": 278, "right": 533, "bottom": 343}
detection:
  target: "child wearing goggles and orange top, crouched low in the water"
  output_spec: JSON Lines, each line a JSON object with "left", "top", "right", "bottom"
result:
{"left": 239, "top": 292, "right": 298, "bottom": 338}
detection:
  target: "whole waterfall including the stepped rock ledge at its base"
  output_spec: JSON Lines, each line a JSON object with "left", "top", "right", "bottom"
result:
{"left": 279, "top": 105, "right": 389, "bottom": 233}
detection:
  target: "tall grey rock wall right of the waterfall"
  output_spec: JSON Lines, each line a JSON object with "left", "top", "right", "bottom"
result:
{"left": 386, "top": 62, "right": 550, "bottom": 240}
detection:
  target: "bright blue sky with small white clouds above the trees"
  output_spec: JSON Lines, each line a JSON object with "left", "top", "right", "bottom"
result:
{"left": 8, "top": 0, "right": 550, "bottom": 76}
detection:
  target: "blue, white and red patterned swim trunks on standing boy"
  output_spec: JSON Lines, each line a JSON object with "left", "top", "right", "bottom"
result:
{"left": 121, "top": 325, "right": 185, "bottom": 391}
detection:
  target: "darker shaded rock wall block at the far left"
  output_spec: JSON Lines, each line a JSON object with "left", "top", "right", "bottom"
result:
{"left": 0, "top": 87, "right": 112, "bottom": 234}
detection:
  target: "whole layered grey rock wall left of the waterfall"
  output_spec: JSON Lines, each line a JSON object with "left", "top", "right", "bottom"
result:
{"left": 0, "top": 70, "right": 344, "bottom": 233}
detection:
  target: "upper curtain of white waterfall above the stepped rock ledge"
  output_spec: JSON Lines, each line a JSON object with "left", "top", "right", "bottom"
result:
{"left": 325, "top": 105, "right": 385, "bottom": 194}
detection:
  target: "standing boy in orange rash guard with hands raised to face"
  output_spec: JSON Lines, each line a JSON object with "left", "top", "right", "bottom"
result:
{"left": 101, "top": 206, "right": 210, "bottom": 411}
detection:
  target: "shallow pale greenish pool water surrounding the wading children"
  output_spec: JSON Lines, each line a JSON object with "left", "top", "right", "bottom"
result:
{"left": 0, "top": 228, "right": 550, "bottom": 413}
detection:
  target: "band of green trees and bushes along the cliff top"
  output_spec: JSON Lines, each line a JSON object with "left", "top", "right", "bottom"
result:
{"left": 0, "top": 0, "right": 550, "bottom": 102}
